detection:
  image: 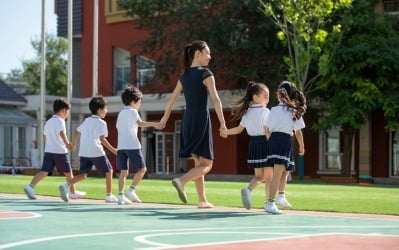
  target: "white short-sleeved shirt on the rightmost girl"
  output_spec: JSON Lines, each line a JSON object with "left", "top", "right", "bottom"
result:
{"left": 266, "top": 103, "right": 305, "bottom": 136}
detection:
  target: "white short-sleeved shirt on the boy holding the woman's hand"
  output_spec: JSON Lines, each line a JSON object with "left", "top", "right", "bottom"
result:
{"left": 116, "top": 106, "right": 141, "bottom": 149}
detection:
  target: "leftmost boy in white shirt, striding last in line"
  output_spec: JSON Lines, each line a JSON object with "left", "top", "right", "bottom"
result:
{"left": 24, "top": 99, "right": 86, "bottom": 199}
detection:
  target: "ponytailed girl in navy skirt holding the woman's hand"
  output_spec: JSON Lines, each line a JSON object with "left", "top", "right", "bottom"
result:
{"left": 226, "top": 82, "right": 273, "bottom": 209}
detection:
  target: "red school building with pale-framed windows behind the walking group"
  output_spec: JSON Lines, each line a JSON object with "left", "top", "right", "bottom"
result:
{"left": 50, "top": 0, "right": 399, "bottom": 183}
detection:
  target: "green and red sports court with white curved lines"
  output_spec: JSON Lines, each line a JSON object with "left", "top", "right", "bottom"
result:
{"left": 0, "top": 194, "right": 399, "bottom": 250}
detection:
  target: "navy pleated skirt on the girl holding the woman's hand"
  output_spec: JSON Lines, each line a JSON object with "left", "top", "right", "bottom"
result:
{"left": 247, "top": 135, "right": 268, "bottom": 168}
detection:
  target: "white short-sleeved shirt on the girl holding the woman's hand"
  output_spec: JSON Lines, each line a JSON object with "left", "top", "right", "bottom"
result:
{"left": 240, "top": 104, "right": 270, "bottom": 136}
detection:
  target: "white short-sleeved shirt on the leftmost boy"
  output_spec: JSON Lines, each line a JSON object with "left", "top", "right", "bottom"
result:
{"left": 43, "top": 115, "right": 68, "bottom": 154}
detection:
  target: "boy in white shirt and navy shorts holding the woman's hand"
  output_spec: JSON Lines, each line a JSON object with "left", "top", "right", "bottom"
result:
{"left": 116, "top": 86, "right": 160, "bottom": 205}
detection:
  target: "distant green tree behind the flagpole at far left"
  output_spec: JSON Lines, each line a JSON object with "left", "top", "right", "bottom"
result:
{"left": 9, "top": 35, "right": 68, "bottom": 96}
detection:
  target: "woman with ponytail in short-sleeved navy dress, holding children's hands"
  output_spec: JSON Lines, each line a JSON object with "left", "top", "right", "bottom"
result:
{"left": 161, "top": 41, "right": 226, "bottom": 208}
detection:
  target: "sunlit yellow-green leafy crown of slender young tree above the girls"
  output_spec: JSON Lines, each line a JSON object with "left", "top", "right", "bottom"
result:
{"left": 263, "top": 0, "right": 352, "bottom": 95}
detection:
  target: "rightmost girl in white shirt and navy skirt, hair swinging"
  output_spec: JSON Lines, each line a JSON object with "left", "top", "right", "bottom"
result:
{"left": 265, "top": 81, "right": 306, "bottom": 214}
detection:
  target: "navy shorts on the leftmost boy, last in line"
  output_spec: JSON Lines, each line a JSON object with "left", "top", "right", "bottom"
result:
{"left": 41, "top": 152, "right": 72, "bottom": 173}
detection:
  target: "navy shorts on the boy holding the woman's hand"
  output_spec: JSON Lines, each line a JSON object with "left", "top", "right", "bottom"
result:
{"left": 116, "top": 149, "right": 145, "bottom": 170}
